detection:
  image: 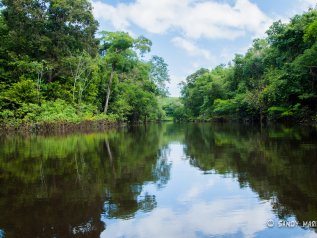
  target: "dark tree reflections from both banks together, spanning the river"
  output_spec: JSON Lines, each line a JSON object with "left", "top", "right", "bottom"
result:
{"left": 0, "top": 123, "right": 317, "bottom": 238}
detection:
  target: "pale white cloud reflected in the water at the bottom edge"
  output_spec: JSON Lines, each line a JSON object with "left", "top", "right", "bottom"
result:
{"left": 101, "top": 198, "right": 271, "bottom": 238}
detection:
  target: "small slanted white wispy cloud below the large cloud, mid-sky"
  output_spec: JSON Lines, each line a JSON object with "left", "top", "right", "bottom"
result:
{"left": 172, "top": 37, "right": 212, "bottom": 60}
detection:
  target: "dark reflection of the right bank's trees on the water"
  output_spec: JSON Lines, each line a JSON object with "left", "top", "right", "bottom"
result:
{"left": 184, "top": 124, "right": 317, "bottom": 230}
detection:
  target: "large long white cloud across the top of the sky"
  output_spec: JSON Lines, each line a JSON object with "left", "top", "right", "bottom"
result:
{"left": 93, "top": 0, "right": 271, "bottom": 39}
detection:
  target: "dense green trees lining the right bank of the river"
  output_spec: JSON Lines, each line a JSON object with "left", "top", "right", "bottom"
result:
{"left": 179, "top": 8, "right": 317, "bottom": 121}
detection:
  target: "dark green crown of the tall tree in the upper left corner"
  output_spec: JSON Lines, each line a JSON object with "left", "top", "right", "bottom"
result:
{"left": 0, "top": 0, "right": 98, "bottom": 82}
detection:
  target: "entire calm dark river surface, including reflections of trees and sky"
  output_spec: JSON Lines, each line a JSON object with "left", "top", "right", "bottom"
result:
{"left": 0, "top": 123, "right": 317, "bottom": 238}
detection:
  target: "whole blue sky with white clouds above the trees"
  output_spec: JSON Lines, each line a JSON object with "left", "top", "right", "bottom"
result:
{"left": 92, "top": 0, "right": 317, "bottom": 97}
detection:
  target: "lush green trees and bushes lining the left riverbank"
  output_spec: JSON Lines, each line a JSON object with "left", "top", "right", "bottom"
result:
{"left": 0, "top": 0, "right": 169, "bottom": 124}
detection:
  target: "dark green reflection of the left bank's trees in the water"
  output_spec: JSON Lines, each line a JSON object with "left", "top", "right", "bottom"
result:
{"left": 0, "top": 125, "right": 169, "bottom": 237}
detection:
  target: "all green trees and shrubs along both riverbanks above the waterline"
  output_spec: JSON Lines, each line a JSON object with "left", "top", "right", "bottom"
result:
{"left": 0, "top": 0, "right": 317, "bottom": 132}
